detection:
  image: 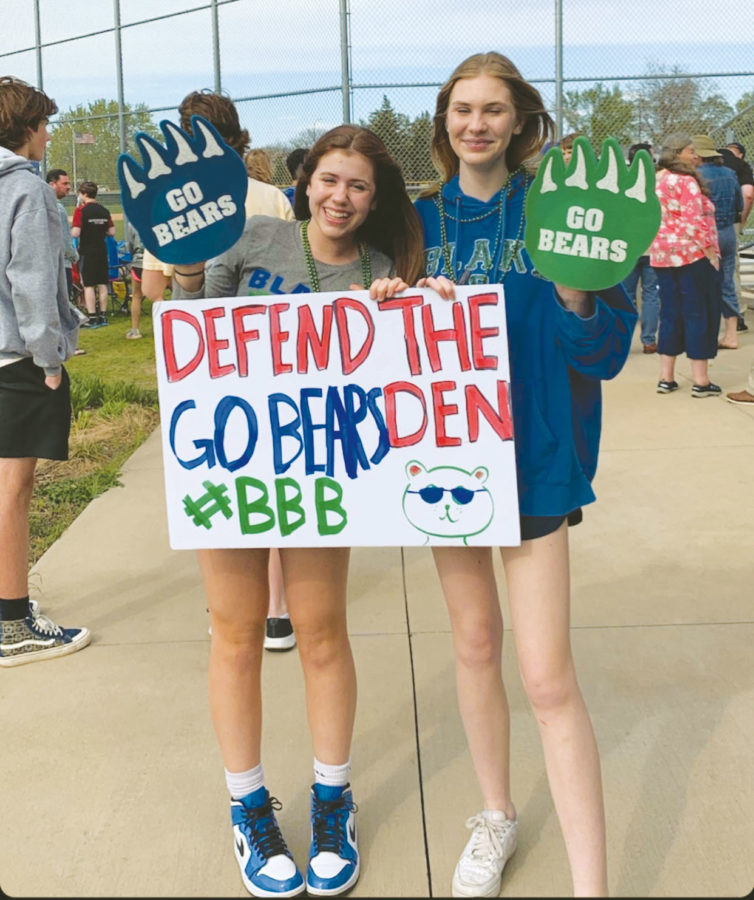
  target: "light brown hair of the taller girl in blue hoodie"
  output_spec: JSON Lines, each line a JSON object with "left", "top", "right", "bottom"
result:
{"left": 431, "top": 51, "right": 555, "bottom": 181}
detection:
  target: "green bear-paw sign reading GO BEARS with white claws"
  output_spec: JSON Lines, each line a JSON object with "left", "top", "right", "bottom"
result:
{"left": 525, "top": 137, "right": 660, "bottom": 291}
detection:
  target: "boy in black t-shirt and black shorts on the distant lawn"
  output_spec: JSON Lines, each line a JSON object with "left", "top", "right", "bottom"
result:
{"left": 71, "top": 181, "right": 115, "bottom": 328}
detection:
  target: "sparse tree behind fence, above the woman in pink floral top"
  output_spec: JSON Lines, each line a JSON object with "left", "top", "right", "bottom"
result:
{"left": 640, "top": 66, "right": 733, "bottom": 146}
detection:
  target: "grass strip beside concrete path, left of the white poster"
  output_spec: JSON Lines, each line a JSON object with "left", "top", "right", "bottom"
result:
{"left": 29, "top": 301, "right": 164, "bottom": 565}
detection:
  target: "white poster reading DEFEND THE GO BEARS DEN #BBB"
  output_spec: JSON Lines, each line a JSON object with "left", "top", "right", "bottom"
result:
{"left": 153, "top": 285, "right": 520, "bottom": 549}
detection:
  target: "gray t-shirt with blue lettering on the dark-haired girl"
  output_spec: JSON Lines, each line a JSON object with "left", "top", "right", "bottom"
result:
{"left": 173, "top": 216, "right": 395, "bottom": 300}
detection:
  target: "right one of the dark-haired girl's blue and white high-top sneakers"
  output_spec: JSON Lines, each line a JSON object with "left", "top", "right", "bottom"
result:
{"left": 306, "top": 784, "right": 359, "bottom": 897}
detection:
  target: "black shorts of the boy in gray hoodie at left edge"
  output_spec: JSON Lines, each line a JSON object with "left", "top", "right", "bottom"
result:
{"left": 0, "top": 358, "right": 71, "bottom": 459}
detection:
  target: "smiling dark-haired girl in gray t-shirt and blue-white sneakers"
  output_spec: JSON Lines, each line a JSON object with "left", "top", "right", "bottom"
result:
{"left": 174, "top": 125, "right": 422, "bottom": 897}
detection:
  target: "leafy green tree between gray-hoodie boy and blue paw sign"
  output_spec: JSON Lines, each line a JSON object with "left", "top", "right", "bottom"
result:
{"left": 47, "top": 99, "right": 164, "bottom": 190}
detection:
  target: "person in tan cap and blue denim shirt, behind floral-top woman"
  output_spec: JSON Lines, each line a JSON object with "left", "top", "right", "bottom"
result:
{"left": 692, "top": 134, "right": 744, "bottom": 350}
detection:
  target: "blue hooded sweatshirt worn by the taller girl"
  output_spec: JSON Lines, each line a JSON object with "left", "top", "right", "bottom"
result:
{"left": 415, "top": 173, "right": 637, "bottom": 516}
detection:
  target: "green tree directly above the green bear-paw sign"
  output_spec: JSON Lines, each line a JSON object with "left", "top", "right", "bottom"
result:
{"left": 563, "top": 82, "right": 635, "bottom": 152}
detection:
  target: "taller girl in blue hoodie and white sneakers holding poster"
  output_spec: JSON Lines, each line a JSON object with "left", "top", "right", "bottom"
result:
{"left": 372, "top": 53, "right": 636, "bottom": 897}
